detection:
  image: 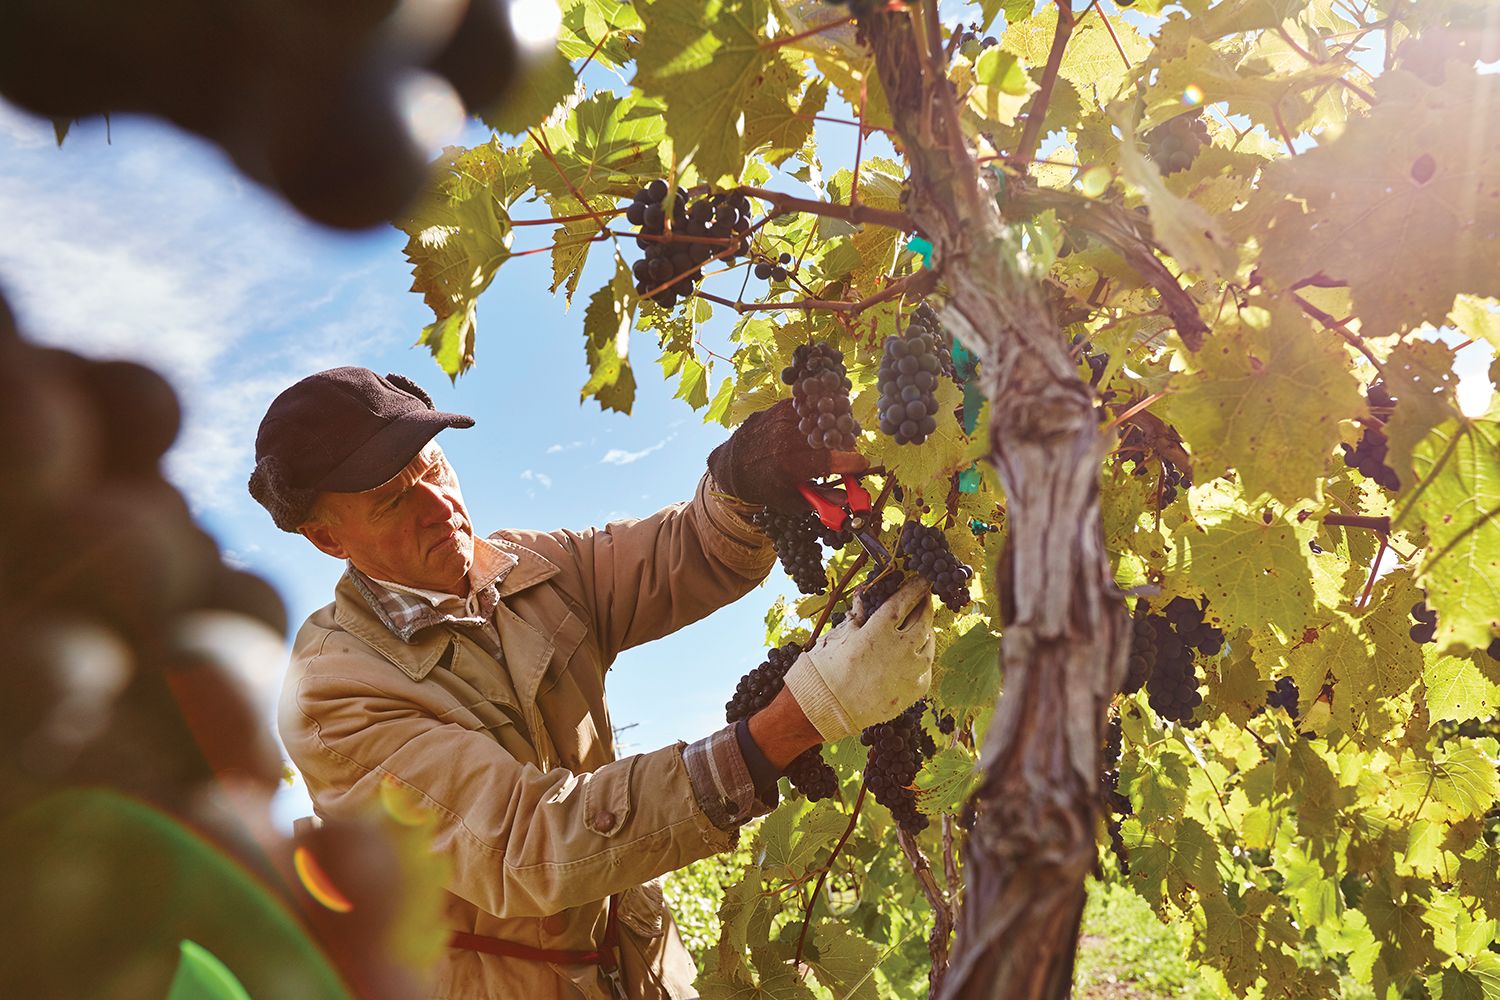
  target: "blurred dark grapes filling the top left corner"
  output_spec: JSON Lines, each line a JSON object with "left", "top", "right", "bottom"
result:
{"left": 0, "top": 0, "right": 546, "bottom": 228}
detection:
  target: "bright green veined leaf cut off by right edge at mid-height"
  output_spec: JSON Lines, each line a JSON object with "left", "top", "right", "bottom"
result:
{"left": 1398, "top": 405, "right": 1500, "bottom": 652}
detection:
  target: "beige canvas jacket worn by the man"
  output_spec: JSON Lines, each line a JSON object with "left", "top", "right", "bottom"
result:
{"left": 281, "top": 477, "right": 774, "bottom": 1000}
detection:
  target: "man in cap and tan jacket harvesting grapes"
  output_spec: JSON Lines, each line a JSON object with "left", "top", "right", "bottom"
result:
{"left": 249, "top": 367, "right": 933, "bottom": 1000}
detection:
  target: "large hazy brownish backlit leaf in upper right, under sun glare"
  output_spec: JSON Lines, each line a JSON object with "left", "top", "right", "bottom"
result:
{"left": 1260, "top": 70, "right": 1500, "bottom": 336}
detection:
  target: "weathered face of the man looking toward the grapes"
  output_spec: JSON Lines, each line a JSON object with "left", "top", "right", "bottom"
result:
{"left": 302, "top": 442, "right": 474, "bottom": 595}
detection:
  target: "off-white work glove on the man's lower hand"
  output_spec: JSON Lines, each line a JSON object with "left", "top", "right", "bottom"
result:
{"left": 786, "top": 577, "right": 933, "bottom": 742}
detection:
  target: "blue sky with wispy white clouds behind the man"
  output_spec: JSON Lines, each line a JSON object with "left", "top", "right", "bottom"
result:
{"left": 0, "top": 95, "right": 840, "bottom": 822}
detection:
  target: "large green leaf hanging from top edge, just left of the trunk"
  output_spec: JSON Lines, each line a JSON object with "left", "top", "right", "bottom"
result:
{"left": 635, "top": 0, "right": 779, "bottom": 183}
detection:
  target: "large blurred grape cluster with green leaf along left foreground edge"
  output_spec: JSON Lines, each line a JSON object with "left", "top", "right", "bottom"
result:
{"left": 0, "top": 293, "right": 444, "bottom": 1000}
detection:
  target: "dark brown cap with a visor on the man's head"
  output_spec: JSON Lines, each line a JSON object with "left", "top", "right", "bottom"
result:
{"left": 251, "top": 367, "right": 474, "bottom": 531}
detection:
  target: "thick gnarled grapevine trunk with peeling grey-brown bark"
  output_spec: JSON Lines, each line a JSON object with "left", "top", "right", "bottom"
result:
{"left": 861, "top": 3, "right": 1130, "bottom": 1000}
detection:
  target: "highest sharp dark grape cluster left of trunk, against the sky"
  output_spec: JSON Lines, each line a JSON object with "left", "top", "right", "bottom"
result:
{"left": 626, "top": 178, "right": 750, "bottom": 309}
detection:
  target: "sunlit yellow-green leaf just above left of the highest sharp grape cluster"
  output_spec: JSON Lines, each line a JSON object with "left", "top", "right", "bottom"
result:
{"left": 530, "top": 90, "right": 666, "bottom": 210}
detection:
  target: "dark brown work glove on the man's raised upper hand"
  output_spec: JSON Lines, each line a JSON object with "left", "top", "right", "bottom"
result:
{"left": 708, "top": 399, "right": 869, "bottom": 514}
